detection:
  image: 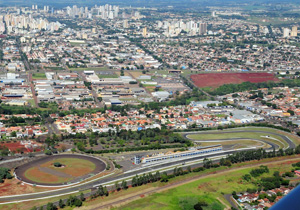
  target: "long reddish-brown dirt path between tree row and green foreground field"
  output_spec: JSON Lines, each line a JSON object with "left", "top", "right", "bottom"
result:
{"left": 80, "top": 156, "right": 300, "bottom": 210}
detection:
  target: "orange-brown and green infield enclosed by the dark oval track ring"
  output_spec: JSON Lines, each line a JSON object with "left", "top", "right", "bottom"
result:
{"left": 25, "top": 158, "right": 96, "bottom": 184}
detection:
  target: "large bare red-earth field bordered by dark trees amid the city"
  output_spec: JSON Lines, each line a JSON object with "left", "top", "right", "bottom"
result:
{"left": 191, "top": 73, "right": 279, "bottom": 88}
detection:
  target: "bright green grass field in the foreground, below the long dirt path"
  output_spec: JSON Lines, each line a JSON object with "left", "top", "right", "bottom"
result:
{"left": 115, "top": 159, "right": 299, "bottom": 210}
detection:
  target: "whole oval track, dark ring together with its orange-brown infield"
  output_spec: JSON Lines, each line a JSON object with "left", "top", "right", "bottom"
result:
{"left": 15, "top": 154, "right": 106, "bottom": 186}
